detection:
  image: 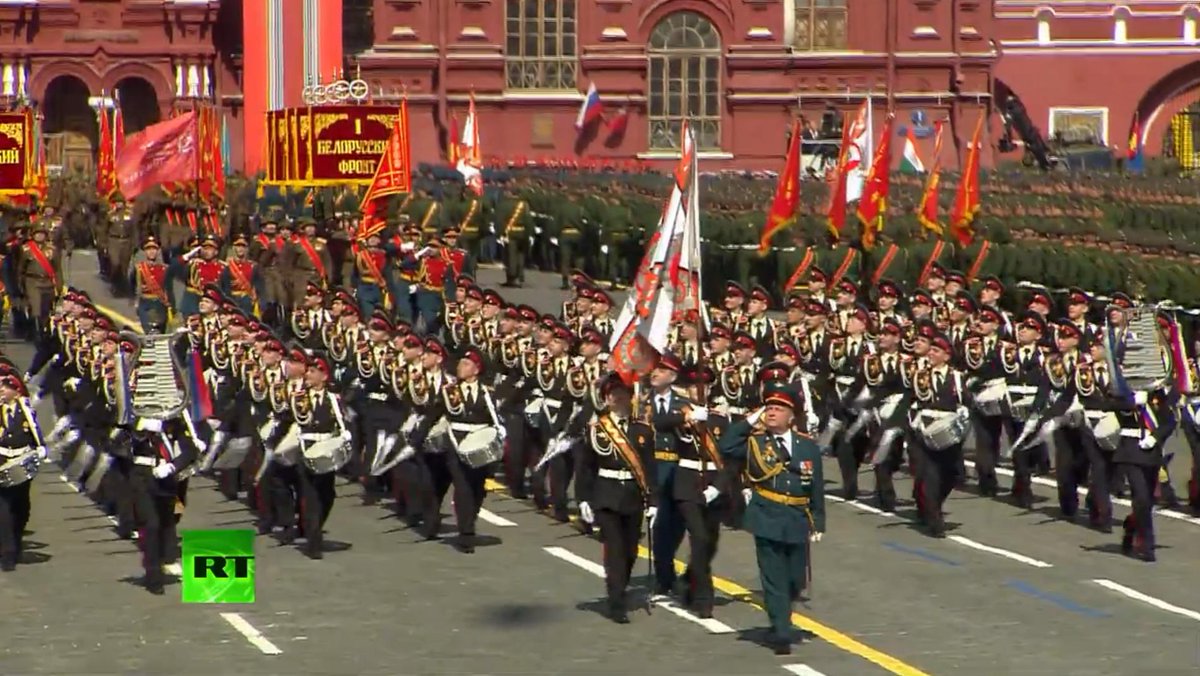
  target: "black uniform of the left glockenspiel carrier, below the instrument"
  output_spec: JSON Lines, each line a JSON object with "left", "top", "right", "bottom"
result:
{"left": 130, "top": 418, "right": 197, "bottom": 594}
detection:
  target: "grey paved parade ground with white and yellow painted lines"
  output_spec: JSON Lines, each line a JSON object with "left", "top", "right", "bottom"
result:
{"left": 0, "top": 252, "right": 1200, "bottom": 676}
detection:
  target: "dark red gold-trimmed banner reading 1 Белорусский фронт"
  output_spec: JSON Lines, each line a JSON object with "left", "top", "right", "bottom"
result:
{"left": 266, "top": 106, "right": 400, "bottom": 186}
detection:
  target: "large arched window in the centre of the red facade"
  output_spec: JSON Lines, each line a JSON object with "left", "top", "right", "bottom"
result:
{"left": 647, "top": 12, "right": 721, "bottom": 150}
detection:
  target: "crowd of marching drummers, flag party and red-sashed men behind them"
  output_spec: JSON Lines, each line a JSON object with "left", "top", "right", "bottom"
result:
{"left": 0, "top": 204, "right": 1200, "bottom": 653}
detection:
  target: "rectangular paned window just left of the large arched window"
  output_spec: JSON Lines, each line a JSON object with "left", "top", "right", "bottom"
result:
{"left": 504, "top": 0, "right": 578, "bottom": 90}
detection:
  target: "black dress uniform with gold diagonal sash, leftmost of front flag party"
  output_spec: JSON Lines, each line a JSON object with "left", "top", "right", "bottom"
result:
{"left": 577, "top": 391, "right": 659, "bottom": 623}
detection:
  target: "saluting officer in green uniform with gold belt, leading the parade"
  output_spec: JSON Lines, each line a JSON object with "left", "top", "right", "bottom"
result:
{"left": 720, "top": 387, "right": 826, "bottom": 654}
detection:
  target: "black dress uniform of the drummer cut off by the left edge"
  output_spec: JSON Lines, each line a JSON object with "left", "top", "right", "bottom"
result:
{"left": 0, "top": 381, "right": 46, "bottom": 572}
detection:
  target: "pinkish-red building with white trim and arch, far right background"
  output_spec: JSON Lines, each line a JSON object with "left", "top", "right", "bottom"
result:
{"left": 992, "top": 0, "right": 1200, "bottom": 168}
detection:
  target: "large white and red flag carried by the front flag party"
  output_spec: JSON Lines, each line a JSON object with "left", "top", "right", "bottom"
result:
{"left": 610, "top": 121, "right": 708, "bottom": 383}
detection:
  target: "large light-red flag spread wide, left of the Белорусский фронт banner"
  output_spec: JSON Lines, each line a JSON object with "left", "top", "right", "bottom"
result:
{"left": 116, "top": 112, "right": 199, "bottom": 199}
